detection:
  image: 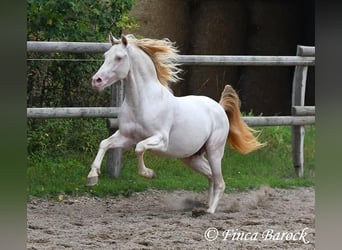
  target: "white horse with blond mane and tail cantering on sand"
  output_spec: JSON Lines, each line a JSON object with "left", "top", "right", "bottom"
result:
{"left": 87, "top": 35, "right": 263, "bottom": 213}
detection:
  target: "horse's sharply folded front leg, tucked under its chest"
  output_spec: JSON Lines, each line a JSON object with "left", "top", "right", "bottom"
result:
{"left": 135, "top": 135, "right": 167, "bottom": 179}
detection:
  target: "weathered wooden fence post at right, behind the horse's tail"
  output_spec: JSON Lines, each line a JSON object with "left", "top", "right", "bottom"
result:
{"left": 292, "top": 45, "right": 314, "bottom": 177}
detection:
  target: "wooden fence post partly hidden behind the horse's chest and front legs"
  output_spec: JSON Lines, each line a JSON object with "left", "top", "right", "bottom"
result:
{"left": 106, "top": 80, "right": 124, "bottom": 177}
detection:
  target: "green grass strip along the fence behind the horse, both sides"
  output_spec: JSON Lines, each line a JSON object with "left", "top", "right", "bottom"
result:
{"left": 27, "top": 126, "right": 315, "bottom": 198}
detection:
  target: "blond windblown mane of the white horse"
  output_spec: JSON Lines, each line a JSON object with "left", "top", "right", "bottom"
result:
{"left": 126, "top": 34, "right": 181, "bottom": 87}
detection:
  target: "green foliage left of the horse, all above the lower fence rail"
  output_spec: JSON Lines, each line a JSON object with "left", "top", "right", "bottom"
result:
{"left": 27, "top": 0, "right": 135, "bottom": 107}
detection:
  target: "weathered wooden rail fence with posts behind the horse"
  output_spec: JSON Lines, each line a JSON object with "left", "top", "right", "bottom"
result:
{"left": 27, "top": 41, "right": 315, "bottom": 177}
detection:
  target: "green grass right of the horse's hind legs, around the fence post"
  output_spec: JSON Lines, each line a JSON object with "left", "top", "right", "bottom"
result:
{"left": 222, "top": 126, "right": 315, "bottom": 190}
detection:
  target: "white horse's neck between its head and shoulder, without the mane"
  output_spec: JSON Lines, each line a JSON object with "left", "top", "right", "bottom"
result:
{"left": 125, "top": 47, "right": 164, "bottom": 108}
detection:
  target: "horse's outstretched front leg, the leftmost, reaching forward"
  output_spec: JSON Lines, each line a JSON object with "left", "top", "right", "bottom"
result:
{"left": 87, "top": 130, "right": 134, "bottom": 186}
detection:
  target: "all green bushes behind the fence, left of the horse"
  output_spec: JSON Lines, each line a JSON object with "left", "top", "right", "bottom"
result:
{"left": 27, "top": 0, "right": 135, "bottom": 162}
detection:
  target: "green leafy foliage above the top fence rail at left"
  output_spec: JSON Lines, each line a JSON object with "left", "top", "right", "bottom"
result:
{"left": 27, "top": 0, "right": 135, "bottom": 42}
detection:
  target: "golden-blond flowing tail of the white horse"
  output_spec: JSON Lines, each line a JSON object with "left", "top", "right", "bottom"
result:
{"left": 220, "top": 85, "right": 265, "bottom": 154}
